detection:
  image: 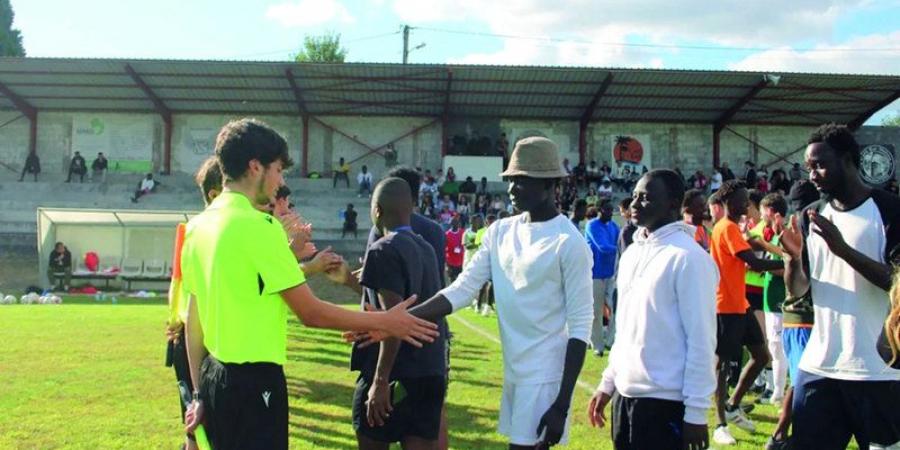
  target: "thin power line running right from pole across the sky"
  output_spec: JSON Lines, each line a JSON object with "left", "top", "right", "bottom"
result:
{"left": 416, "top": 27, "right": 900, "bottom": 52}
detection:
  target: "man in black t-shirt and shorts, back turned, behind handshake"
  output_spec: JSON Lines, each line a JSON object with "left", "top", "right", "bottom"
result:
{"left": 350, "top": 178, "right": 450, "bottom": 450}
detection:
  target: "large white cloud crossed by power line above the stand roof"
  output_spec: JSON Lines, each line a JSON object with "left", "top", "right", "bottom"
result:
{"left": 393, "top": 0, "right": 879, "bottom": 67}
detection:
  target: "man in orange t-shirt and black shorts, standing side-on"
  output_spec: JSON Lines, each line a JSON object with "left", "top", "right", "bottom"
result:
{"left": 710, "top": 180, "right": 783, "bottom": 445}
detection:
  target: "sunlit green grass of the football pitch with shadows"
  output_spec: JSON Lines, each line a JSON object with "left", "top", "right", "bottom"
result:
{"left": 0, "top": 291, "right": 796, "bottom": 450}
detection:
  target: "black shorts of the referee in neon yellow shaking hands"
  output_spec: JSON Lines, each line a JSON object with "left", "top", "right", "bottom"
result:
{"left": 200, "top": 355, "right": 288, "bottom": 450}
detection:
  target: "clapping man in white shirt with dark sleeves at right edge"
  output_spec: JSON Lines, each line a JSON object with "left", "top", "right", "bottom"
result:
{"left": 781, "top": 124, "right": 900, "bottom": 450}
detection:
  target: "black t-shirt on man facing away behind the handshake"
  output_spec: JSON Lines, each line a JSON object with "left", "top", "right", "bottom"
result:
{"left": 350, "top": 231, "right": 448, "bottom": 380}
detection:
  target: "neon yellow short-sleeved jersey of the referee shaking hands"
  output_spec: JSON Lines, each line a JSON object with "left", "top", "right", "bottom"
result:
{"left": 181, "top": 192, "right": 306, "bottom": 364}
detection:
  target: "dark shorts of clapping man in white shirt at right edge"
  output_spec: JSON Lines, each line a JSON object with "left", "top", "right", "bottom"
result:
{"left": 791, "top": 371, "right": 900, "bottom": 450}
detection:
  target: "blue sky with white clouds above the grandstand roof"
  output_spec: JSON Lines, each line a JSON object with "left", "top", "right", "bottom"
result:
{"left": 12, "top": 0, "right": 900, "bottom": 119}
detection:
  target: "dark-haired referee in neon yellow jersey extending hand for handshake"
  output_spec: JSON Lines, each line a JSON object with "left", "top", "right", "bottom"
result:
{"left": 181, "top": 119, "right": 438, "bottom": 449}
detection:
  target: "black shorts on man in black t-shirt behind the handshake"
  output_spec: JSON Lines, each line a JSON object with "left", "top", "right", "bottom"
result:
{"left": 353, "top": 376, "right": 447, "bottom": 442}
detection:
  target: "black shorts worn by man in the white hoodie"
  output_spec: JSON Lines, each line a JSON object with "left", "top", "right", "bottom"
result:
{"left": 612, "top": 393, "right": 684, "bottom": 449}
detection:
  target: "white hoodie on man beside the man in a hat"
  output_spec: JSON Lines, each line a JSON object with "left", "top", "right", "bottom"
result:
{"left": 597, "top": 221, "right": 719, "bottom": 425}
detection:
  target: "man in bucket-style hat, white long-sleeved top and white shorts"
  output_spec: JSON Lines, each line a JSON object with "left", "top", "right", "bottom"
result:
{"left": 360, "top": 137, "right": 593, "bottom": 449}
